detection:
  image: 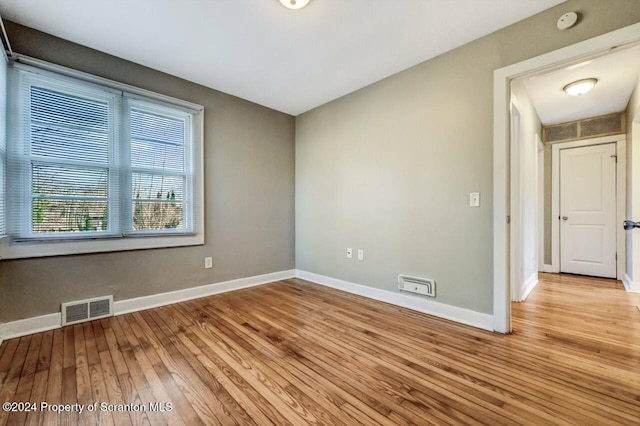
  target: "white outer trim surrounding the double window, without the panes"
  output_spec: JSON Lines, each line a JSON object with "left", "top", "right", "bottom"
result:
{"left": 0, "top": 55, "right": 204, "bottom": 259}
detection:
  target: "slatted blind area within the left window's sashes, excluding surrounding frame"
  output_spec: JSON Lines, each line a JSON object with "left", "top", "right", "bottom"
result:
{"left": 29, "top": 84, "right": 118, "bottom": 234}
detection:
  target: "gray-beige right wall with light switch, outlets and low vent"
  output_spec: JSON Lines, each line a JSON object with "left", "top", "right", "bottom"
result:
{"left": 296, "top": 0, "right": 640, "bottom": 314}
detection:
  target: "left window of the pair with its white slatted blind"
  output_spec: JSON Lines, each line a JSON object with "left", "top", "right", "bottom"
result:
{"left": 9, "top": 68, "right": 120, "bottom": 238}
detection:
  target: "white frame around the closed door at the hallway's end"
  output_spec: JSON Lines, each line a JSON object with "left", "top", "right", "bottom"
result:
{"left": 551, "top": 135, "right": 627, "bottom": 280}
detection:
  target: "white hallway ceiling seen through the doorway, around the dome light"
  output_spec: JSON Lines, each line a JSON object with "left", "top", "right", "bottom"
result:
{"left": 521, "top": 46, "right": 640, "bottom": 125}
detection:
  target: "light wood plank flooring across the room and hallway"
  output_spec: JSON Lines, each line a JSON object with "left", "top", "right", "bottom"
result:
{"left": 0, "top": 274, "right": 640, "bottom": 426}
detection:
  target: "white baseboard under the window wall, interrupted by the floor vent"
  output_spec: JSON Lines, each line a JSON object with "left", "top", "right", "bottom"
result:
{"left": 0, "top": 269, "right": 295, "bottom": 343}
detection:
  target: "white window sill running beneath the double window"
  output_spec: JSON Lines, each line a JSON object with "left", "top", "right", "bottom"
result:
{"left": 0, "top": 233, "right": 204, "bottom": 260}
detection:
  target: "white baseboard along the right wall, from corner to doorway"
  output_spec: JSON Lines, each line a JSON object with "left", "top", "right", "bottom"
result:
{"left": 296, "top": 269, "right": 493, "bottom": 331}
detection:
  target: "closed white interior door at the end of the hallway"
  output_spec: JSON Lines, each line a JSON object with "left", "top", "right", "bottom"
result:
{"left": 560, "top": 143, "right": 616, "bottom": 278}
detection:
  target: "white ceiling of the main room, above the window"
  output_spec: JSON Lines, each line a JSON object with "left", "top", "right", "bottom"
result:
{"left": 0, "top": 0, "right": 564, "bottom": 115}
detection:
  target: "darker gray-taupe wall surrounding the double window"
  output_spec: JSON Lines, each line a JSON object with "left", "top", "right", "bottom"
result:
{"left": 0, "top": 22, "right": 295, "bottom": 322}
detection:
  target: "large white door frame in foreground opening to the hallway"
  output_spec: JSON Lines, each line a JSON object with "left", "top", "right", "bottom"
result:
{"left": 493, "top": 23, "right": 640, "bottom": 333}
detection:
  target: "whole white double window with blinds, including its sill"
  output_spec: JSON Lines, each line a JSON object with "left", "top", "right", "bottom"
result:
{"left": 0, "top": 60, "right": 203, "bottom": 257}
